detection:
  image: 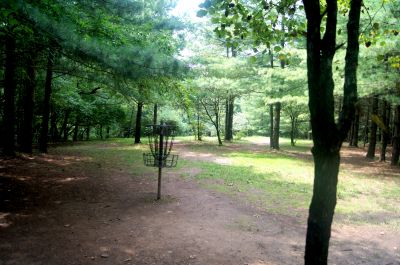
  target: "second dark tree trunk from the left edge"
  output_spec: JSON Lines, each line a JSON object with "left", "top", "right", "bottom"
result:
{"left": 20, "top": 53, "right": 36, "bottom": 153}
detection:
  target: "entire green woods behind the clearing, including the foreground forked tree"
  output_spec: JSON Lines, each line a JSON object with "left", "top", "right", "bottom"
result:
{"left": 0, "top": 0, "right": 400, "bottom": 264}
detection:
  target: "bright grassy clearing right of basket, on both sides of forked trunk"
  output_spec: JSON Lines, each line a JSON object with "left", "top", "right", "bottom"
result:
{"left": 181, "top": 137, "right": 400, "bottom": 229}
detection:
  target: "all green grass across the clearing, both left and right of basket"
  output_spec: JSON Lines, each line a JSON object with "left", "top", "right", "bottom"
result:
{"left": 53, "top": 137, "right": 400, "bottom": 229}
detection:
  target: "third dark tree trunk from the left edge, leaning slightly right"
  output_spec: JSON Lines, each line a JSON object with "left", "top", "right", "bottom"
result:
{"left": 39, "top": 50, "right": 54, "bottom": 153}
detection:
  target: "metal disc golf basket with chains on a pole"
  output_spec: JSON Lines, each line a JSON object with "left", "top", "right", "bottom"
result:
{"left": 143, "top": 123, "right": 178, "bottom": 200}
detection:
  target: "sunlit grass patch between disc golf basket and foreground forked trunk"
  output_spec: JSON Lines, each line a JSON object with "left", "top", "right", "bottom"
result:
{"left": 196, "top": 162, "right": 311, "bottom": 214}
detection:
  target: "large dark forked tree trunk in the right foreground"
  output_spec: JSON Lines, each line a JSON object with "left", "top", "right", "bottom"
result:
{"left": 303, "top": 0, "right": 361, "bottom": 265}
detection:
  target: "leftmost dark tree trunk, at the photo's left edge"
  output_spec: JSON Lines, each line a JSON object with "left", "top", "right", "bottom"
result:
{"left": 2, "top": 36, "right": 16, "bottom": 155}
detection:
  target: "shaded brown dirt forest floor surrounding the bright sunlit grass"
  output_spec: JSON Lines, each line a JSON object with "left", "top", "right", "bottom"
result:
{"left": 0, "top": 138, "right": 400, "bottom": 265}
